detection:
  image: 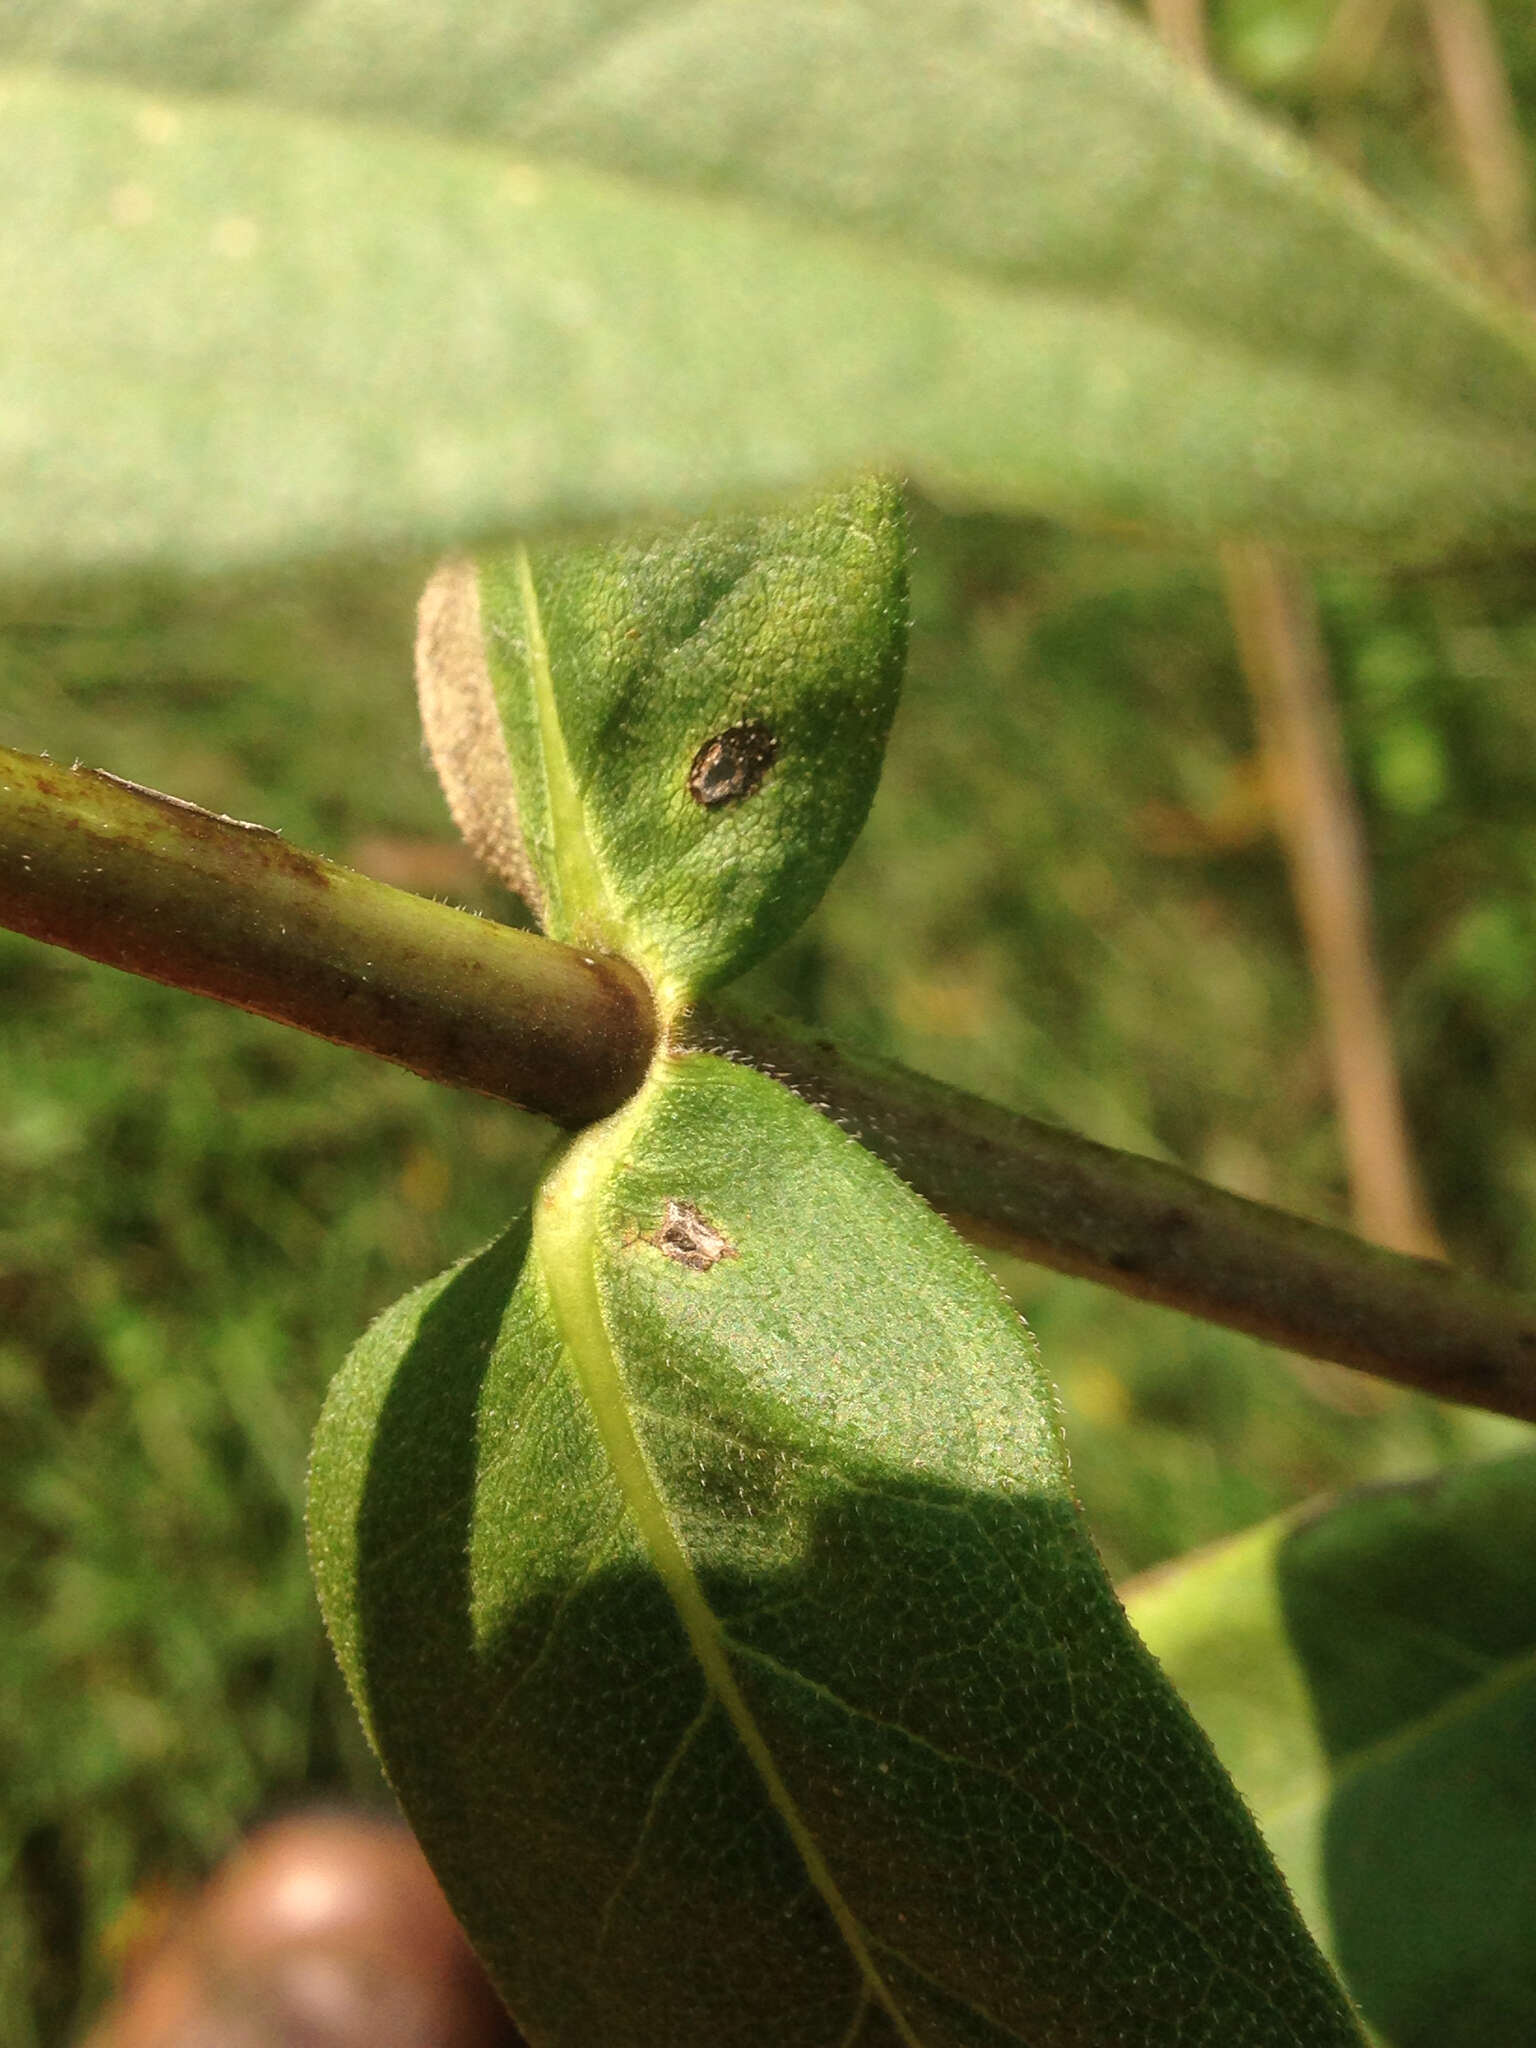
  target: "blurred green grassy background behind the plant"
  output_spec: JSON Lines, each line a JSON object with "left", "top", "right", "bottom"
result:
{"left": 0, "top": 0, "right": 1536, "bottom": 2048}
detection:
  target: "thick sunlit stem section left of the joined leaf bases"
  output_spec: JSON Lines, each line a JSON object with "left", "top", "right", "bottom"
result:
{"left": 0, "top": 748, "right": 655, "bottom": 1124}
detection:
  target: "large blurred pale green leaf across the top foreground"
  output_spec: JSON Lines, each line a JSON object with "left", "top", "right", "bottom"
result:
{"left": 0, "top": 0, "right": 1536, "bottom": 573}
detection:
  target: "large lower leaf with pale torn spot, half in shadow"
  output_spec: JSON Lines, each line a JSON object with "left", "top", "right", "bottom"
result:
{"left": 311, "top": 1055, "right": 1358, "bottom": 2048}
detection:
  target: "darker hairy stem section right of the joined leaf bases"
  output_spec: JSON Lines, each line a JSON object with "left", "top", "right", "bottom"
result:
{"left": 692, "top": 1012, "right": 1536, "bottom": 1421}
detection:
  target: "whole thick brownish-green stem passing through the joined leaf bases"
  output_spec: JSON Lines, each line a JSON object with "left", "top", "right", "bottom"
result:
{"left": 0, "top": 748, "right": 1536, "bottom": 1421}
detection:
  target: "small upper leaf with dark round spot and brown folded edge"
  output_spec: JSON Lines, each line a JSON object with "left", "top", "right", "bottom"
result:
{"left": 418, "top": 481, "right": 907, "bottom": 1014}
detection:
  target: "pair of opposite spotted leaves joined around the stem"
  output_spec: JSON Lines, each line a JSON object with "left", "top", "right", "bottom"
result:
{"left": 311, "top": 483, "right": 1360, "bottom": 2048}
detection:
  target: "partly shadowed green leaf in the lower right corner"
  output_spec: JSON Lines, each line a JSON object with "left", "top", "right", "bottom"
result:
{"left": 1128, "top": 1454, "right": 1536, "bottom": 2048}
